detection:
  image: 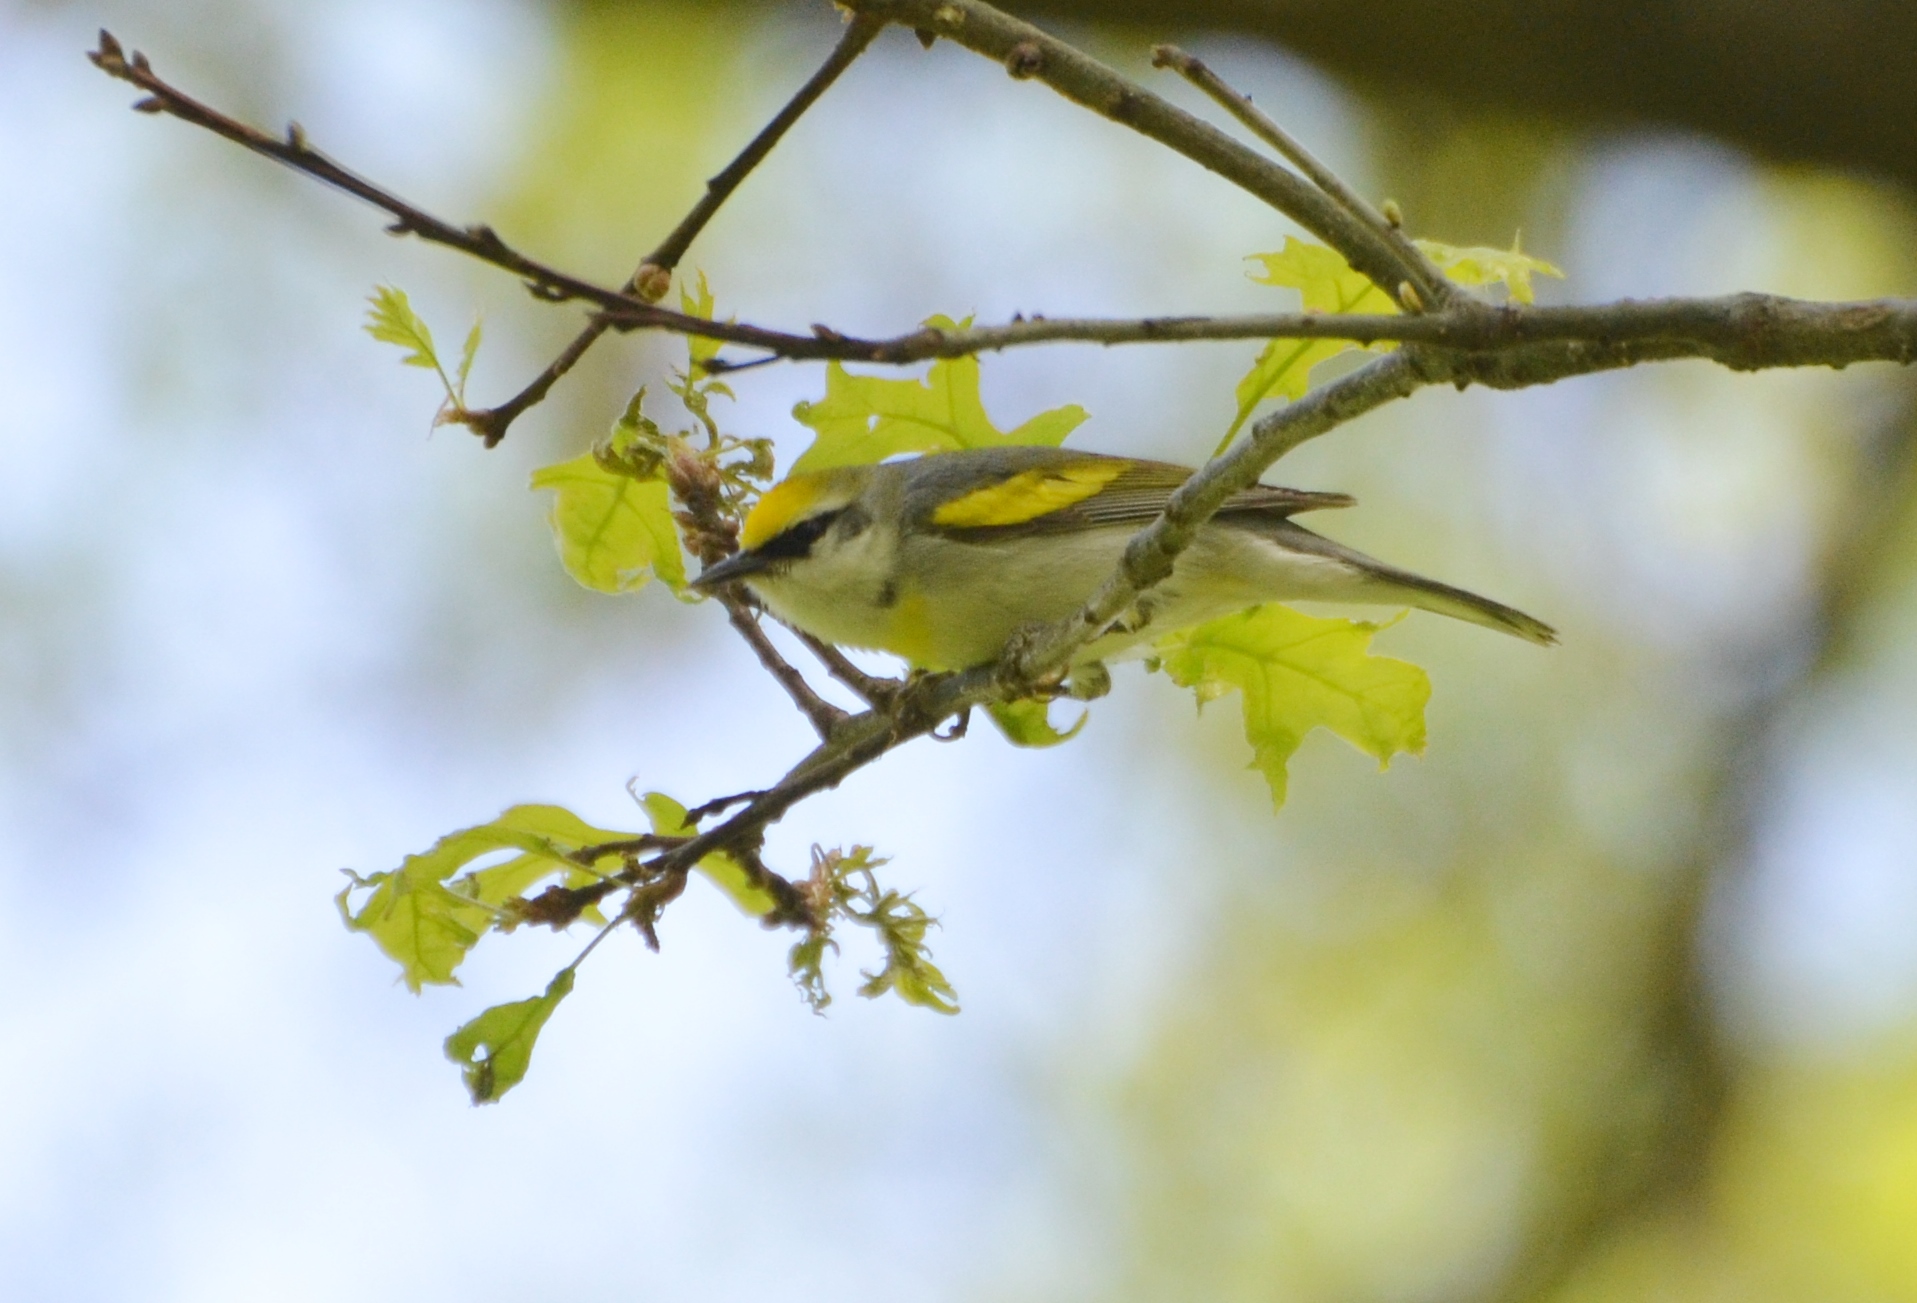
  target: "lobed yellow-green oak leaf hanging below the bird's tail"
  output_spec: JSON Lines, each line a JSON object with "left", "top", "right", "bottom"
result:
{"left": 1154, "top": 606, "right": 1432, "bottom": 807}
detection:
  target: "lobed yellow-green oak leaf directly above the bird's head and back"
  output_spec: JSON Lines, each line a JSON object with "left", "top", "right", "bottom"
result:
{"left": 792, "top": 316, "right": 1087, "bottom": 471}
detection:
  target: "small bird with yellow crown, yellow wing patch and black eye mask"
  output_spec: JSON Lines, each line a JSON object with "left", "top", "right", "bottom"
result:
{"left": 696, "top": 446, "right": 1557, "bottom": 669}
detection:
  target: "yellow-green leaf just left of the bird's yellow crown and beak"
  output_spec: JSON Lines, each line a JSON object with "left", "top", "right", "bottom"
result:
{"left": 533, "top": 452, "right": 686, "bottom": 592}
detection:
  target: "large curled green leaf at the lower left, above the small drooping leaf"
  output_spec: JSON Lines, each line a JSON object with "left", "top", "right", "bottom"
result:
{"left": 337, "top": 805, "right": 633, "bottom": 994}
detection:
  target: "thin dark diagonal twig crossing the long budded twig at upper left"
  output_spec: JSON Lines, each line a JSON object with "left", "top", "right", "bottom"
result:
{"left": 466, "top": 15, "right": 886, "bottom": 448}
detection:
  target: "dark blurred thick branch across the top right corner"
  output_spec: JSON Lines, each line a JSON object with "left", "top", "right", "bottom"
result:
{"left": 1012, "top": 0, "right": 1917, "bottom": 186}
